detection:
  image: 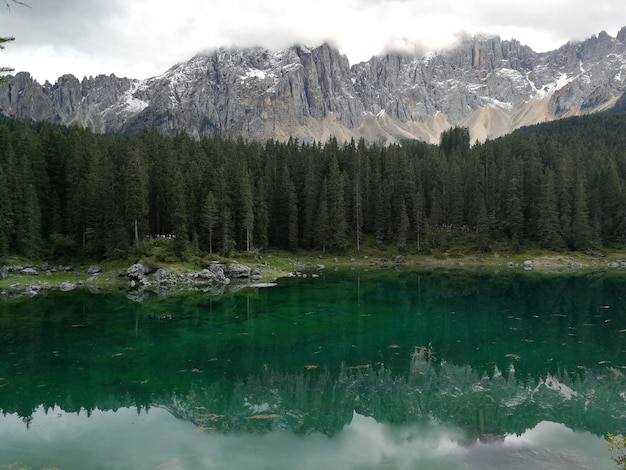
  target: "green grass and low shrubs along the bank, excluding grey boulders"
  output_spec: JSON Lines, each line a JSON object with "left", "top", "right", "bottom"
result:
{"left": 0, "top": 237, "right": 626, "bottom": 291}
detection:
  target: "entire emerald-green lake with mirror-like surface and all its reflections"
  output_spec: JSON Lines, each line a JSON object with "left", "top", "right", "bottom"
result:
{"left": 0, "top": 270, "right": 626, "bottom": 470}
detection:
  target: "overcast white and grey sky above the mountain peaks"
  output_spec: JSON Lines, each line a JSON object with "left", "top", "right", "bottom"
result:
{"left": 0, "top": 0, "right": 626, "bottom": 83}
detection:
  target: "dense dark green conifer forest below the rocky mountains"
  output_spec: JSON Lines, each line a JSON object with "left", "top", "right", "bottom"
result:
{"left": 0, "top": 113, "right": 626, "bottom": 257}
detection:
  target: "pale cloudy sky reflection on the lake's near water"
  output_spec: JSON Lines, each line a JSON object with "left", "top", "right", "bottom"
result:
{"left": 0, "top": 408, "right": 614, "bottom": 470}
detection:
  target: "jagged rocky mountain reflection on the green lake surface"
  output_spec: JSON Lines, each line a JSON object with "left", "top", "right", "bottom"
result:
{"left": 158, "top": 346, "right": 626, "bottom": 439}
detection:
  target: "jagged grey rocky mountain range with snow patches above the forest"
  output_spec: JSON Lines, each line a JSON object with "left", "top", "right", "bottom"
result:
{"left": 0, "top": 27, "right": 626, "bottom": 142}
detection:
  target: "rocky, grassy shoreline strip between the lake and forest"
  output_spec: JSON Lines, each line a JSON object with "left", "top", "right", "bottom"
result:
{"left": 0, "top": 252, "right": 626, "bottom": 300}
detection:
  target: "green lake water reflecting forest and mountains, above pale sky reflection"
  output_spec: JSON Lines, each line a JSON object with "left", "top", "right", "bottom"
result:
{"left": 0, "top": 273, "right": 626, "bottom": 439}
